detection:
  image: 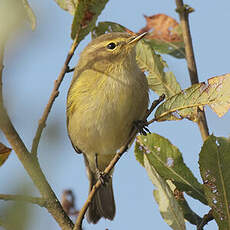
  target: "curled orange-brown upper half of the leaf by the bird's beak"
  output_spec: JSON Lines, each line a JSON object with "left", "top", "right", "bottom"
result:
{"left": 139, "top": 14, "right": 183, "bottom": 42}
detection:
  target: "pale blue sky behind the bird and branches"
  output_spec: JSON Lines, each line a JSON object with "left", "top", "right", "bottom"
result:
{"left": 0, "top": 0, "right": 230, "bottom": 230}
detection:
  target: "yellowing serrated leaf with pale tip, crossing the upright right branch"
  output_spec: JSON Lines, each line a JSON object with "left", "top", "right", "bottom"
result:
{"left": 155, "top": 74, "right": 230, "bottom": 121}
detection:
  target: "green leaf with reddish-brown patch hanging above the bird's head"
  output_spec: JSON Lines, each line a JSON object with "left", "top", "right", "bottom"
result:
{"left": 71, "top": 0, "right": 108, "bottom": 42}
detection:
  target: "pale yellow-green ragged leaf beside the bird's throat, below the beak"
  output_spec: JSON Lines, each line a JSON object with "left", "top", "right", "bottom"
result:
{"left": 136, "top": 41, "right": 181, "bottom": 97}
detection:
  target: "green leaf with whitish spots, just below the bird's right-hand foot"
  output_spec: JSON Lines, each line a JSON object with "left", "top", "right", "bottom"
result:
{"left": 135, "top": 133, "right": 207, "bottom": 204}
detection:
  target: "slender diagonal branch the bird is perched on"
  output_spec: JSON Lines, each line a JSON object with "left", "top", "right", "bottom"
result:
{"left": 73, "top": 95, "right": 165, "bottom": 230}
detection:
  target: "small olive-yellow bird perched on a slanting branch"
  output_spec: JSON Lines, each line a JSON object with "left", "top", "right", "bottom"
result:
{"left": 67, "top": 32, "right": 149, "bottom": 223}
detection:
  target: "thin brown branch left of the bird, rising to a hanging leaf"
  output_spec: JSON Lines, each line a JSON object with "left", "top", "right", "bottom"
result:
{"left": 31, "top": 35, "right": 79, "bottom": 154}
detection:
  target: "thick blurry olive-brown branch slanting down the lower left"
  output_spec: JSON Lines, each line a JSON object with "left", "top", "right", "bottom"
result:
{"left": 0, "top": 44, "right": 73, "bottom": 230}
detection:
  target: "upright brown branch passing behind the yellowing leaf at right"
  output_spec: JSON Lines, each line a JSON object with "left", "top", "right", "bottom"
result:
{"left": 175, "top": 0, "right": 209, "bottom": 141}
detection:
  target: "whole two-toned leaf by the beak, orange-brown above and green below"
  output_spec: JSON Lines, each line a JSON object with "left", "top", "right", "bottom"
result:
{"left": 139, "top": 14, "right": 185, "bottom": 58}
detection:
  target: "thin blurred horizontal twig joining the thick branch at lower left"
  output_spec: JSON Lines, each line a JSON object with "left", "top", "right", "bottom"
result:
{"left": 0, "top": 194, "right": 48, "bottom": 207}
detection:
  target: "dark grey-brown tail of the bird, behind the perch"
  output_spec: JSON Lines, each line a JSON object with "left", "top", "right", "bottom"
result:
{"left": 87, "top": 169, "right": 116, "bottom": 224}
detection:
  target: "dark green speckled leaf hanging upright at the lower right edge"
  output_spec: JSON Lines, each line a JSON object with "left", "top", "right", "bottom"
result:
{"left": 199, "top": 135, "right": 230, "bottom": 230}
